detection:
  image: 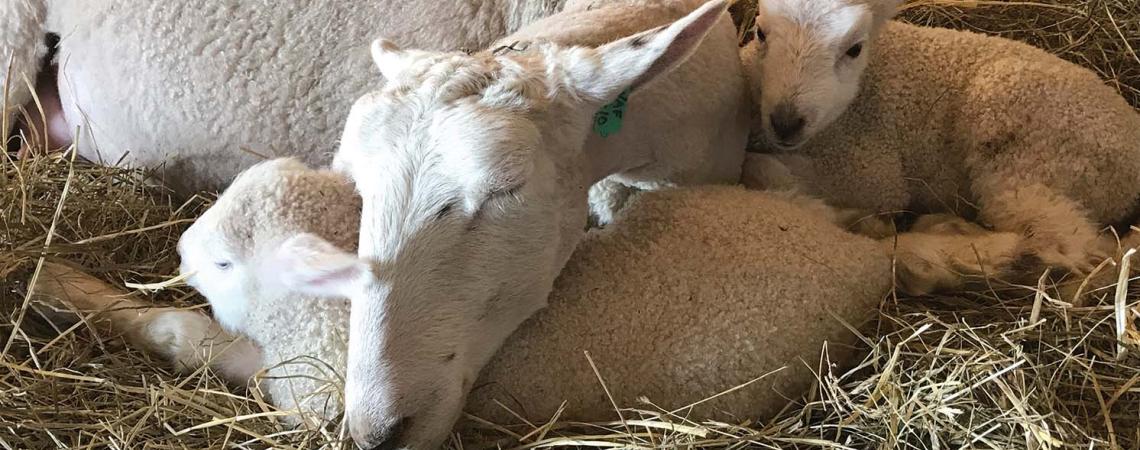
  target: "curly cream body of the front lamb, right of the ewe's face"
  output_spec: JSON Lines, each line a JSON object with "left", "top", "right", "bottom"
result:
{"left": 467, "top": 187, "right": 890, "bottom": 423}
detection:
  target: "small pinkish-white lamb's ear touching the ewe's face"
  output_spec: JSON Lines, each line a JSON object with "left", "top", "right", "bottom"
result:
{"left": 264, "top": 234, "right": 368, "bottom": 297}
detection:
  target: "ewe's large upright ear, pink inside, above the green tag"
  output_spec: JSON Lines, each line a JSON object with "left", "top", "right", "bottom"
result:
{"left": 569, "top": 0, "right": 728, "bottom": 101}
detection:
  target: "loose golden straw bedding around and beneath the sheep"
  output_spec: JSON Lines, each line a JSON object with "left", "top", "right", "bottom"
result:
{"left": 0, "top": 0, "right": 1140, "bottom": 449}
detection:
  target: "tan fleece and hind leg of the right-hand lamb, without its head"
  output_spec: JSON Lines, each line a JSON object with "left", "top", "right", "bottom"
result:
{"left": 742, "top": 22, "right": 1140, "bottom": 285}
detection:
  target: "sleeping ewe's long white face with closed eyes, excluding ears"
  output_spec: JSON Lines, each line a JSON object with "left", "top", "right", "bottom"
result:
{"left": 336, "top": 55, "right": 570, "bottom": 448}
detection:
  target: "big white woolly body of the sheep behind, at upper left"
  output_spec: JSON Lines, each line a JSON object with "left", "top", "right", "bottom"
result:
{"left": 0, "top": 0, "right": 747, "bottom": 209}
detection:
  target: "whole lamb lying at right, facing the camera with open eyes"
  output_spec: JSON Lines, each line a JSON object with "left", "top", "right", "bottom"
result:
{"left": 742, "top": 0, "right": 1140, "bottom": 293}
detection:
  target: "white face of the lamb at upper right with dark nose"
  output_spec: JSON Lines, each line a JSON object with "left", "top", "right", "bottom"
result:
{"left": 752, "top": 0, "right": 893, "bottom": 149}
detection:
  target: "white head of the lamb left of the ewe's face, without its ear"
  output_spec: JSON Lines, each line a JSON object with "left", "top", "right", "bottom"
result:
{"left": 178, "top": 158, "right": 360, "bottom": 332}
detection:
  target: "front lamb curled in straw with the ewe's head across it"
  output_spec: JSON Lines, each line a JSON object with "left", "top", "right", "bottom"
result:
{"left": 34, "top": 158, "right": 890, "bottom": 444}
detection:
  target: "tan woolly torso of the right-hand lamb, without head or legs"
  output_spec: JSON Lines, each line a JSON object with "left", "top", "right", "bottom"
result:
{"left": 752, "top": 22, "right": 1140, "bottom": 223}
